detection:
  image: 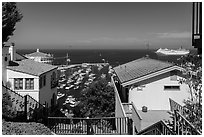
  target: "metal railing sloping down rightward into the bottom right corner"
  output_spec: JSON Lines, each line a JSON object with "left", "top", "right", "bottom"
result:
{"left": 174, "top": 110, "right": 201, "bottom": 135}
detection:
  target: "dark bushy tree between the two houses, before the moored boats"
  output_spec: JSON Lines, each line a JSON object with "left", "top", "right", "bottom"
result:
{"left": 74, "top": 79, "right": 115, "bottom": 118}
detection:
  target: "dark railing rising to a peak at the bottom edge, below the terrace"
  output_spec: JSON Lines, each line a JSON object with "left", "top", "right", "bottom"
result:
{"left": 137, "top": 120, "right": 175, "bottom": 135}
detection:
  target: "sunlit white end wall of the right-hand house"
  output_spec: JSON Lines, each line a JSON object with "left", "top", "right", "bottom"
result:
{"left": 129, "top": 73, "right": 190, "bottom": 110}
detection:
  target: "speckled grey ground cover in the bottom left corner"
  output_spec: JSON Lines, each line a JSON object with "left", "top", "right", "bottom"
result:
{"left": 2, "top": 120, "right": 53, "bottom": 135}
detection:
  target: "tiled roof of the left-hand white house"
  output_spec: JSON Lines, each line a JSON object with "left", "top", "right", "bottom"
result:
{"left": 7, "top": 59, "right": 57, "bottom": 76}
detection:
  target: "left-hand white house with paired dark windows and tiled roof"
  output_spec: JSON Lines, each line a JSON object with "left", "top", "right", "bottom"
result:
{"left": 7, "top": 59, "right": 58, "bottom": 107}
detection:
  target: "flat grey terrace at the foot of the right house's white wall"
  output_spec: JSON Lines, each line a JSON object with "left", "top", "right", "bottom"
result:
{"left": 138, "top": 110, "right": 172, "bottom": 130}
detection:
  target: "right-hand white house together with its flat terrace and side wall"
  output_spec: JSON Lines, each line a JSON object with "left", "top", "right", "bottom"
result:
{"left": 112, "top": 57, "right": 190, "bottom": 131}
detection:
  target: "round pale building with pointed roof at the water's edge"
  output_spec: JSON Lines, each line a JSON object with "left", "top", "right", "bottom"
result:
{"left": 25, "top": 49, "right": 54, "bottom": 64}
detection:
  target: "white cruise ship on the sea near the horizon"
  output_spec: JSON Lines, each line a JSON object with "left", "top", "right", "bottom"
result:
{"left": 155, "top": 48, "right": 190, "bottom": 56}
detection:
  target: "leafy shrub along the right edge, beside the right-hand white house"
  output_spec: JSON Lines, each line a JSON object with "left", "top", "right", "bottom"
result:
{"left": 176, "top": 54, "right": 202, "bottom": 131}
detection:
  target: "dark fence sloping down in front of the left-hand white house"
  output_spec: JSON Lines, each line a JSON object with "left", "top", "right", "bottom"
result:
{"left": 2, "top": 84, "right": 48, "bottom": 122}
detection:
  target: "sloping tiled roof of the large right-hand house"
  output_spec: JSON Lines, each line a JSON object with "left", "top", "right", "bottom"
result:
{"left": 113, "top": 57, "right": 174, "bottom": 83}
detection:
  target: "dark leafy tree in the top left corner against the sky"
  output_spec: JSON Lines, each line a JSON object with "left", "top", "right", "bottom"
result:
{"left": 2, "top": 2, "right": 23, "bottom": 45}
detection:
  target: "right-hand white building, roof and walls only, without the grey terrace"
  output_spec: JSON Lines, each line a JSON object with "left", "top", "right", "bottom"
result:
{"left": 114, "top": 58, "right": 190, "bottom": 110}
